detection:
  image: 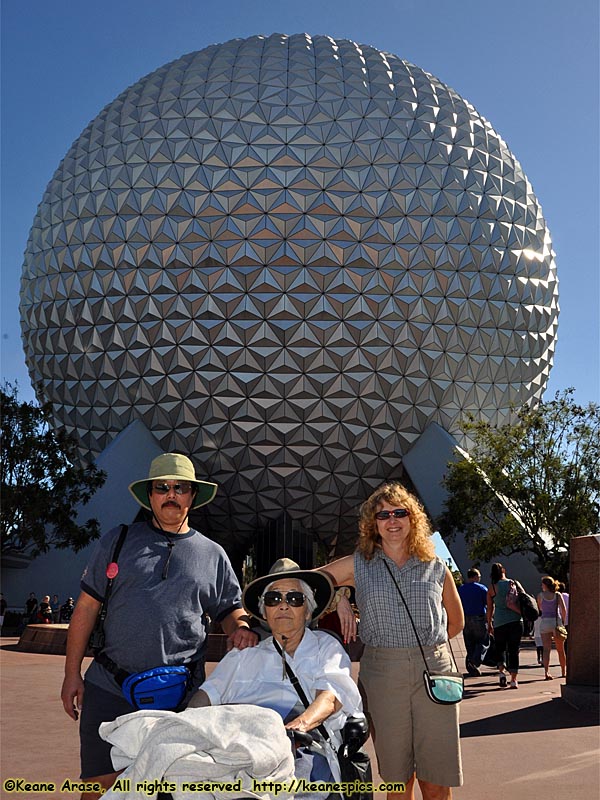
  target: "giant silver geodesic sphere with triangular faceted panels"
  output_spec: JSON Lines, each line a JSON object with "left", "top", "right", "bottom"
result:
{"left": 21, "top": 34, "right": 558, "bottom": 552}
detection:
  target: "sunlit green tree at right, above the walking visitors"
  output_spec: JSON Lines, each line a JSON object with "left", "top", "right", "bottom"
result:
{"left": 438, "top": 389, "right": 600, "bottom": 580}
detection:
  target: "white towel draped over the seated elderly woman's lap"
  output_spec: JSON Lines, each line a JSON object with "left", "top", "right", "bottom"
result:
{"left": 99, "top": 705, "right": 294, "bottom": 800}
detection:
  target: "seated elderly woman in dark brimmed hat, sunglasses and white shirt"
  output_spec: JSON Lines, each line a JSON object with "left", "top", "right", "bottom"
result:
{"left": 188, "top": 558, "right": 363, "bottom": 782}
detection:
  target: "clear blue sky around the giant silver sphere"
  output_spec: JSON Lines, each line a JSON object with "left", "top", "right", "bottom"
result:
{"left": 1, "top": 0, "right": 600, "bottom": 568}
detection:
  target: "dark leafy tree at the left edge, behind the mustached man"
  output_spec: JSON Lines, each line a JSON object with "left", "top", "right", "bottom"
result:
{"left": 0, "top": 383, "right": 106, "bottom": 557}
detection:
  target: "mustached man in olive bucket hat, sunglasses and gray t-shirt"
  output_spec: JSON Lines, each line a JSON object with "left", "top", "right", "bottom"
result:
{"left": 61, "top": 453, "right": 259, "bottom": 800}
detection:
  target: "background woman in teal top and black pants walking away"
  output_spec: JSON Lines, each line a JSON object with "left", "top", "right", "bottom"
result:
{"left": 487, "top": 563, "right": 523, "bottom": 689}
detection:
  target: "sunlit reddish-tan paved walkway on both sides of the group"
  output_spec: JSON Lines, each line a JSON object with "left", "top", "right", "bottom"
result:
{"left": 0, "top": 639, "right": 600, "bottom": 800}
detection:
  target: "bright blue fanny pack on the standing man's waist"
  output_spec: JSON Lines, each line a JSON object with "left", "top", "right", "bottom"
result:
{"left": 121, "top": 666, "right": 191, "bottom": 711}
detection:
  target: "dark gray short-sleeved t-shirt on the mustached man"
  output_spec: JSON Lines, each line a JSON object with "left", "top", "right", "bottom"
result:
{"left": 81, "top": 522, "right": 242, "bottom": 694}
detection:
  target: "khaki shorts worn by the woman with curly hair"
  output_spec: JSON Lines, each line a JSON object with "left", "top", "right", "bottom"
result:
{"left": 359, "top": 644, "right": 463, "bottom": 786}
